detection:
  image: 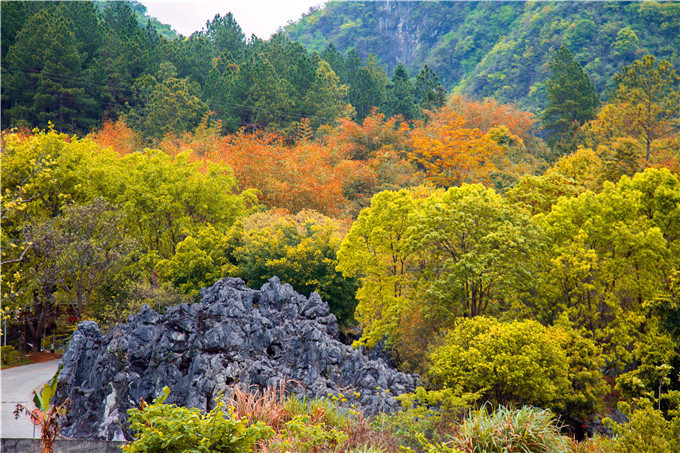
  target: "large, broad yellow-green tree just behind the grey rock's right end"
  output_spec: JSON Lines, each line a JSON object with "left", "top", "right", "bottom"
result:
{"left": 338, "top": 185, "right": 540, "bottom": 354}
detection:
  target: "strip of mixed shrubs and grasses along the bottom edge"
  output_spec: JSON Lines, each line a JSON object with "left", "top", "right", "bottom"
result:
{"left": 124, "top": 381, "right": 678, "bottom": 453}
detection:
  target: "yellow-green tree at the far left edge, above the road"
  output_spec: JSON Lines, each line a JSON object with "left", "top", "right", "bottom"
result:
{"left": 0, "top": 127, "right": 113, "bottom": 351}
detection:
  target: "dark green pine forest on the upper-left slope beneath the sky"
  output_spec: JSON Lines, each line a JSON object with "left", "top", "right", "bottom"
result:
{"left": 2, "top": 1, "right": 445, "bottom": 135}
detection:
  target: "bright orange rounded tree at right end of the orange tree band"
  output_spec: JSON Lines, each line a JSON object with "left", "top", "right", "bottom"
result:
{"left": 409, "top": 106, "right": 501, "bottom": 187}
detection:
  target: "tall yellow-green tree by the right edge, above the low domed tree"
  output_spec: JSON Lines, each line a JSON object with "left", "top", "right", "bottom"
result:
{"left": 535, "top": 170, "right": 677, "bottom": 369}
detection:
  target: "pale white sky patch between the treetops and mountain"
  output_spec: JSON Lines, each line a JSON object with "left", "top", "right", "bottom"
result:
{"left": 140, "top": 0, "right": 324, "bottom": 39}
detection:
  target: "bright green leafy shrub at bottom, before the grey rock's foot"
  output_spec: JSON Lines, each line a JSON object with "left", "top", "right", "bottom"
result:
{"left": 123, "top": 387, "right": 273, "bottom": 453}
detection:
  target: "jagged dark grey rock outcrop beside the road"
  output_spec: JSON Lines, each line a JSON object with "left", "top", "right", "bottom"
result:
{"left": 57, "top": 277, "right": 415, "bottom": 440}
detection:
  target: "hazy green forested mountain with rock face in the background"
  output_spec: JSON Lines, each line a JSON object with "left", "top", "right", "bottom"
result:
{"left": 285, "top": 1, "right": 680, "bottom": 109}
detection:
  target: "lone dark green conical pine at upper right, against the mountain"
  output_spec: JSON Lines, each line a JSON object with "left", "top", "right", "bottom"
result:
{"left": 541, "top": 45, "right": 600, "bottom": 154}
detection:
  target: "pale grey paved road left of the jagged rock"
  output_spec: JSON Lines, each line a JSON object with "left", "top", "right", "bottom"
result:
{"left": 0, "top": 360, "right": 59, "bottom": 439}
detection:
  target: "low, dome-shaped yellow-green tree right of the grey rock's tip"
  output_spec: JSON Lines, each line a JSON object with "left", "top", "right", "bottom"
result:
{"left": 429, "top": 316, "right": 571, "bottom": 409}
